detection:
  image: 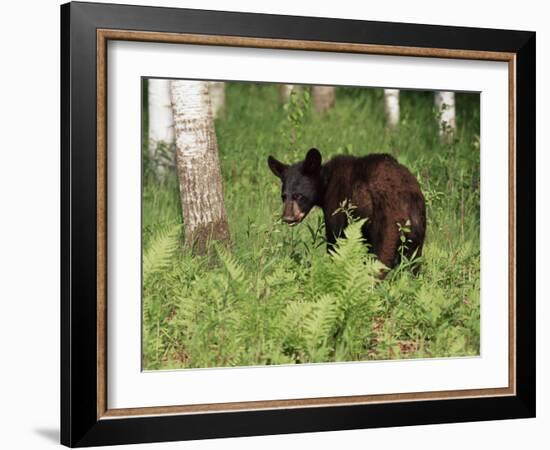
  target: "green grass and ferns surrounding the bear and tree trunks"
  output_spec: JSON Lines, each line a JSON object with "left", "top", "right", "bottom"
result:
{"left": 143, "top": 83, "right": 480, "bottom": 369}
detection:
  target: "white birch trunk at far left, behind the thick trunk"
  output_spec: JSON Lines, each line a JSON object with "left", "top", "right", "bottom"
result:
{"left": 147, "top": 79, "right": 174, "bottom": 180}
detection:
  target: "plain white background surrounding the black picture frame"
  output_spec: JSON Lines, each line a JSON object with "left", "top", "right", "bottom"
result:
{"left": 0, "top": 0, "right": 550, "bottom": 450}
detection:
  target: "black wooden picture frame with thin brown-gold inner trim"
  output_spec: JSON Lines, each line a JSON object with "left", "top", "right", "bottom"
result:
{"left": 61, "top": 2, "right": 535, "bottom": 446}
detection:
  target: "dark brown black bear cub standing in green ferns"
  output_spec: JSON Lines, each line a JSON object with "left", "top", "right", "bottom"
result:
{"left": 268, "top": 148, "right": 426, "bottom": 270}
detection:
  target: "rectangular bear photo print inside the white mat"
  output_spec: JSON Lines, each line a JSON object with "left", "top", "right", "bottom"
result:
{"left": 142, "top": 78, "right": 480, "bottom": 370}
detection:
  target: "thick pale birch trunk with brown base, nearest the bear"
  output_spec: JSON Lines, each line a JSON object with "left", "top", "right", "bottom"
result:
{"left": 171, "top": 81, "right": 229, "bottom": 253}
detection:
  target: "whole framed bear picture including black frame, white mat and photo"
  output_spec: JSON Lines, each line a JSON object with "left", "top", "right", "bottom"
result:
{"left": 61, "top": 3, "right": 535, "bottom": 446}
